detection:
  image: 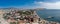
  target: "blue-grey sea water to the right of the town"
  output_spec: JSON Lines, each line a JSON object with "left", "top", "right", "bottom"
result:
{"left": 37, "top": 9, "right": 60, "bottom": 22}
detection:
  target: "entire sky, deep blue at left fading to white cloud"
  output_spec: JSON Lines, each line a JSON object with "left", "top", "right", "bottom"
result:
{"left": 0, "top": 0, "right": 60, "bottom": 9}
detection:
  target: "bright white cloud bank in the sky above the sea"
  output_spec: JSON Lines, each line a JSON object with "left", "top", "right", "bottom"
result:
{"left": 35, "top": 2, "right": 60, "bottom": 9}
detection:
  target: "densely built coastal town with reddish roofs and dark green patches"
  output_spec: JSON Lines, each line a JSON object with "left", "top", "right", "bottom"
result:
{"left": 0, "top": 9, "right": 60, "bottom": 24}
